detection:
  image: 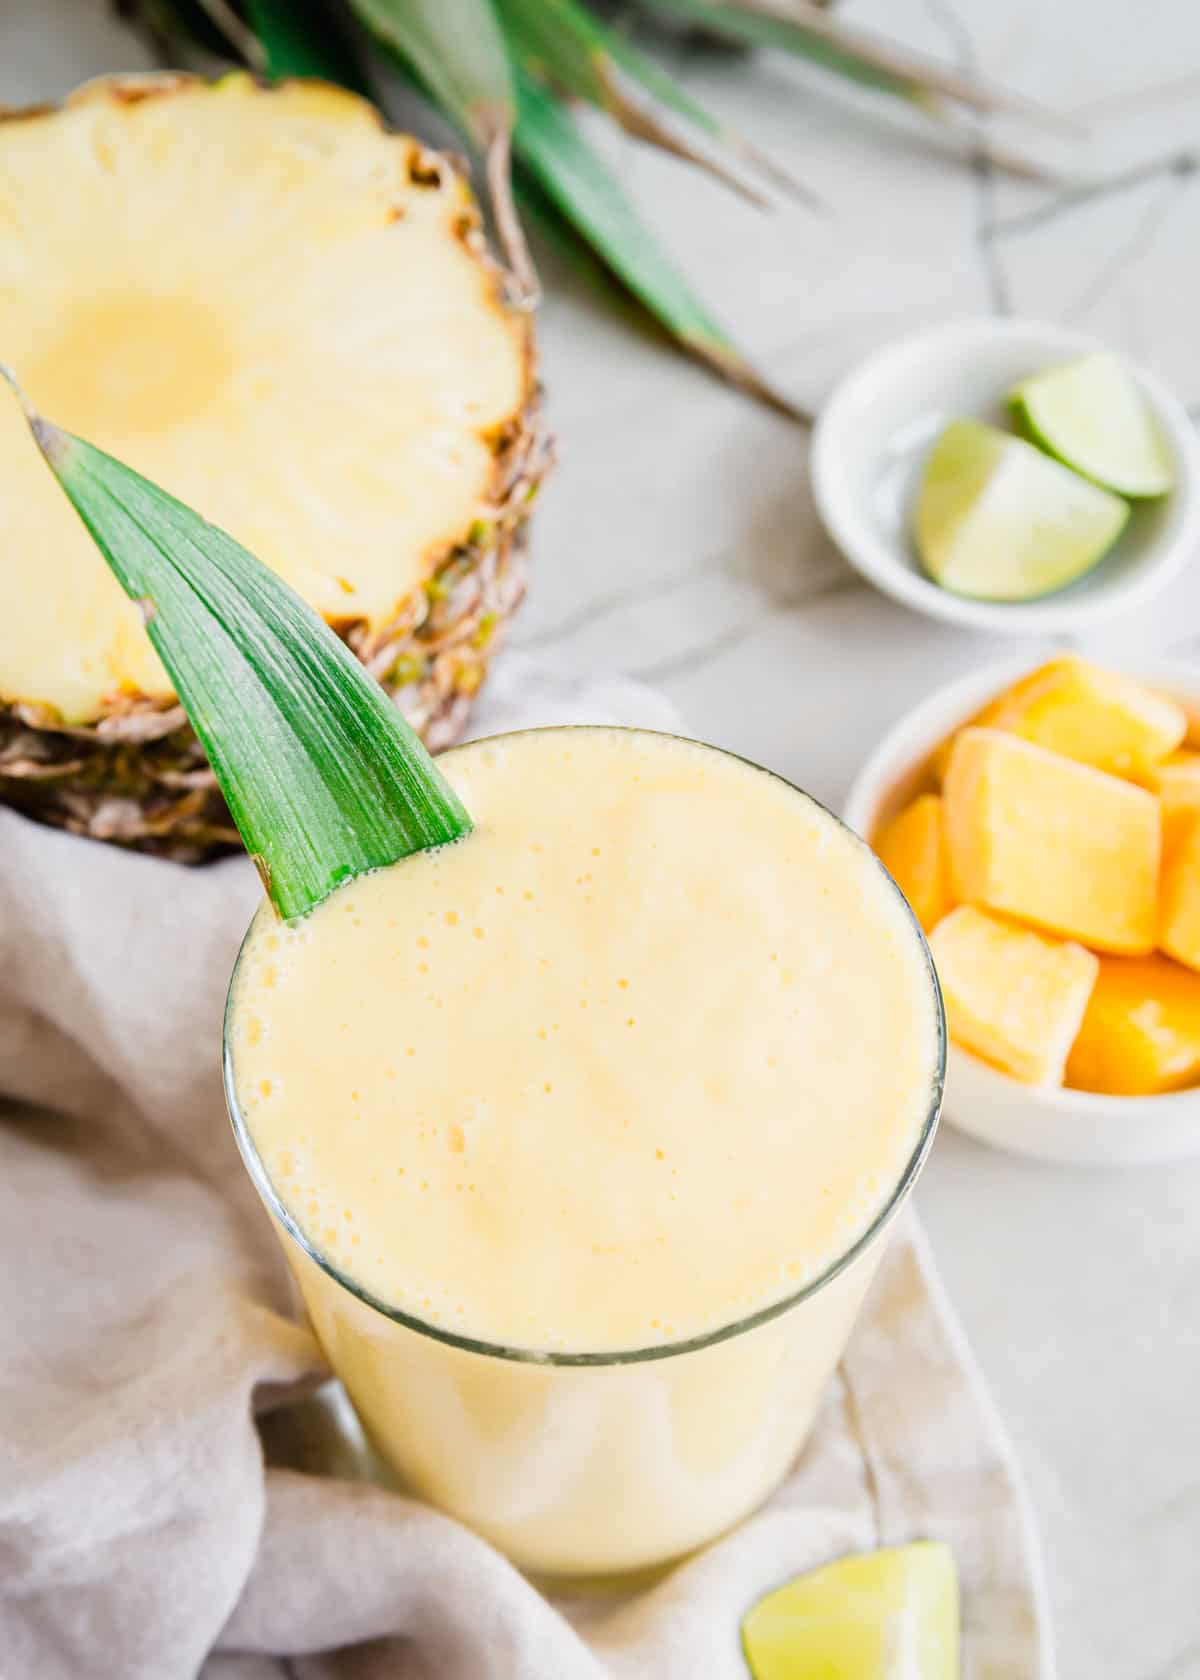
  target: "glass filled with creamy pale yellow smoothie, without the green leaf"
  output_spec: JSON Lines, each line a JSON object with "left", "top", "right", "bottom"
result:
{"left": 225, "top": 727, "right": 945, "bottom": 1576}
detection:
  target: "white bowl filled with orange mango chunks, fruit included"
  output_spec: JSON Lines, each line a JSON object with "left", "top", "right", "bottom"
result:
{"left": 845, "top": 654, "right": 1200, "bottom": 1164}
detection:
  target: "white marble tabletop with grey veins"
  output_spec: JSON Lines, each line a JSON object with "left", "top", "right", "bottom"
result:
{"left": 0, "top": 0, "right": 1200, "bottom": 1680}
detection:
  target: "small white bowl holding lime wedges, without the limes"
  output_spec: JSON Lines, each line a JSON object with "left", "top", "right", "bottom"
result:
{"left": 810, "top": 319, "right": 1200, "bottom": 635}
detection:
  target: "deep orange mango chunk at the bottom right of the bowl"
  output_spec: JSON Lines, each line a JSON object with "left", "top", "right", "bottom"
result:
{"left": 1067, "top": 956, "right": 1200, "bottom": 1097}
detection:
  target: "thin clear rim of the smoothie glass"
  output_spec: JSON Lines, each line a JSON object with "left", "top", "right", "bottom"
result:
{"left": 222, "top": 724, "right": 946, "bottom": 1366}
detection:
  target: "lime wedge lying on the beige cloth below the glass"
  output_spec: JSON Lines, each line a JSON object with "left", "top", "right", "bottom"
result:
{"left": 741, "top": 1541, "right": 958, "bottom": 1680}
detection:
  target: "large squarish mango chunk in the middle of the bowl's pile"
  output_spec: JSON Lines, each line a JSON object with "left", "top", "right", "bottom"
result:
{"left": 945, "top": 729, "right": 1161, "bottom": 956}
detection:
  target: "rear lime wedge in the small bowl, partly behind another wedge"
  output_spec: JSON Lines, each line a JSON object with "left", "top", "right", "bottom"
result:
{"left": 1008, "top": 353, "right": 1173, "bottom": 496}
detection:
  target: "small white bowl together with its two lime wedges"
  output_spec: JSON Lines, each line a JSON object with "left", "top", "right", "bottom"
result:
{"left": 812, "top": 319, "right": 1200, "bottom": 637}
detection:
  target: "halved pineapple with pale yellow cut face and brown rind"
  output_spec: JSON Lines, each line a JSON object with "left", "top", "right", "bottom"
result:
{"left": 0, "top": 76, "right": 548, "bottom": 857}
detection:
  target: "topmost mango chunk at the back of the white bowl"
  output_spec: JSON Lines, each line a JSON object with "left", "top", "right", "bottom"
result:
{"left": 975, "top": 654, "right": 1188, "bottom": 780}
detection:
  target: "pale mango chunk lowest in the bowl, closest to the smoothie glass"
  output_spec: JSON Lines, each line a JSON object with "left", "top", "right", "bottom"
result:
{"left": 929, "top": 904, "right": 1099, "bottom": 1085}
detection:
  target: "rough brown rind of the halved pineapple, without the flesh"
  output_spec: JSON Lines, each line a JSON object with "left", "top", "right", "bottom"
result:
{"left": 0, "top": 76, "right": 553, "bottom": 862}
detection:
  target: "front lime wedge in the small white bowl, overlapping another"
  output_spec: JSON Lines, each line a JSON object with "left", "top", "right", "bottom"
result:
{"left": 914, "top": 420, "right": 1129, "bottom": 601}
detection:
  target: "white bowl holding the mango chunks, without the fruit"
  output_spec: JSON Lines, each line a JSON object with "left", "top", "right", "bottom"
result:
{"left": 844, "top": 660, "right": 1200, "bottom": 1166}
